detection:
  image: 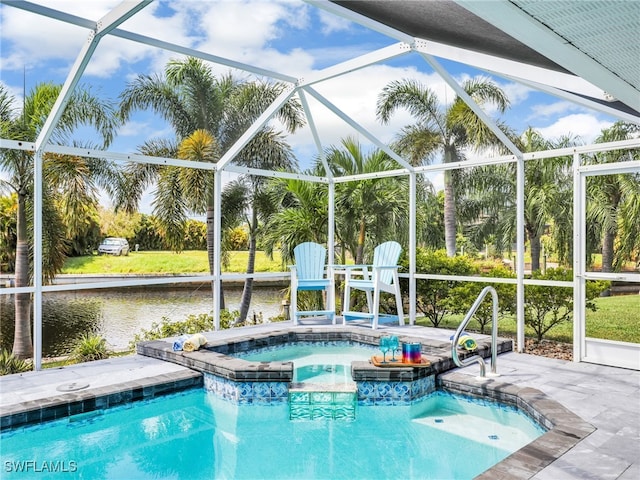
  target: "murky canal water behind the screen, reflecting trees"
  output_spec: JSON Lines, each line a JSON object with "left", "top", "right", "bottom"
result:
{"left": 0, "top": 284, "right": 283, "bottom": 357}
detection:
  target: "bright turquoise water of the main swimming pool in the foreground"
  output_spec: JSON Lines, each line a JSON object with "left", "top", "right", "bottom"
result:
{"left": 0, "top": 389, "right": 543, "bottom": 480}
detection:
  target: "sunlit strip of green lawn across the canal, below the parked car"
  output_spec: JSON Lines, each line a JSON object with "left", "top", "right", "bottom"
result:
{"left": 61, "top": 250, "right": 284, "bottom": 275}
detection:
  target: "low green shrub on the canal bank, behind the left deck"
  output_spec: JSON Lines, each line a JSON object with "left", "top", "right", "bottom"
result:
{"left": 129, "top": 310, "right": 239, "bottom": 350}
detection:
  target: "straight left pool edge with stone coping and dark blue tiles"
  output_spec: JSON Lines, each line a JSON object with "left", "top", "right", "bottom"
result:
{"left": 0, "top": 370, "right": 203, "bottom": 431}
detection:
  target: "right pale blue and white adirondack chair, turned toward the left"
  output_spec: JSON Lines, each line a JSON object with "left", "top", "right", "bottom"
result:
{"left": 341, "top": 241, "right": 404, "bottom": 329}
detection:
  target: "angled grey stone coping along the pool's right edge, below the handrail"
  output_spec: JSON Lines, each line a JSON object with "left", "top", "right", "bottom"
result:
{"left": 437, "top": 372, "right": 596, "bottom": 480}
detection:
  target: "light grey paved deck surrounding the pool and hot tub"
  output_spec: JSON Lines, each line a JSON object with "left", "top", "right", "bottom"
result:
{"left": 0, "top": 323, "right": 640, "bottom": 480}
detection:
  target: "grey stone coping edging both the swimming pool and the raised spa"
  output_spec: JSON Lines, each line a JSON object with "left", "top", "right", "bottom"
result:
{"left": 0, "top": 327, "right": 596, "bottom": 480}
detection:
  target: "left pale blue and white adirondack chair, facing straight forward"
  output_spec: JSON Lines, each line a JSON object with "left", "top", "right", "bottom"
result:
{"left": 289, "top": 242, "right": 336, "bottom": 325}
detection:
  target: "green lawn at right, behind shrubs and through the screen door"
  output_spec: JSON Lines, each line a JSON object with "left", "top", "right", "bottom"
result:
{"left": 416, "top": 295, "right": 640, "bottom": 343}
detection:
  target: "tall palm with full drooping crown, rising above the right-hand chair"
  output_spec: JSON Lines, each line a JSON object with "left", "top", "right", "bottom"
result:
{"left": 376, "top": 78, "right": 509, "bottom": 257}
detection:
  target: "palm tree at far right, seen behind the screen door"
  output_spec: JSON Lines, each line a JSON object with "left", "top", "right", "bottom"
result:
{"left": 587, "top": 122, "right": 640, "bottom": 272}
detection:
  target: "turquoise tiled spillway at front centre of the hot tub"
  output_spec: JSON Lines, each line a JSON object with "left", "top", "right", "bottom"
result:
{"left": 289, "top": 383, "right": 358, "bottom": 420}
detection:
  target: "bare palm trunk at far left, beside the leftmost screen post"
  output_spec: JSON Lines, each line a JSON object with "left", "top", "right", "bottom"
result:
{"left": 13, "top": 192, "right": 33, "bottom": 358}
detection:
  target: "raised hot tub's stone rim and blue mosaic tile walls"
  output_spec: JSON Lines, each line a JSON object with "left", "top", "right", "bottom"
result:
{"left": 137, "top": 327, "right": 512, "bottom": 405}
